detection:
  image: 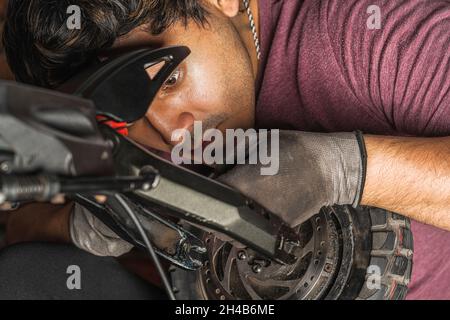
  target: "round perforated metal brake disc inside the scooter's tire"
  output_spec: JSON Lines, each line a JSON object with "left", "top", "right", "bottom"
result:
{"left": 198, "top": 212, "right": 341, "bottom": 300}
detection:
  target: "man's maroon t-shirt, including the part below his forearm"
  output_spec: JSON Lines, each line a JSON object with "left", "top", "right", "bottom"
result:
{"left": 257, "top": 0, "right": 450, "bottom": 299}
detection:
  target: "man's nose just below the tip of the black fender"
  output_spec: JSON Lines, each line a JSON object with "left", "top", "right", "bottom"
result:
{"left": 146, "top": 110, "right": 195, "bottom": 146}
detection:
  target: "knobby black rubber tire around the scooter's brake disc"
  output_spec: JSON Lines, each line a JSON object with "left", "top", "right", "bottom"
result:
{"left": 170, "top": 206, "right": 413, "bottom": 300}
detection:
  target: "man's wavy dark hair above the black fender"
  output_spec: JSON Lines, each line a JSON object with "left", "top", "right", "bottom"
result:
{"left": 3, "top": 0, "right": 207, "bottom": 88}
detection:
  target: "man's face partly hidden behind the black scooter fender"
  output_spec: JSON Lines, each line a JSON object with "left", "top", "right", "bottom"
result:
{"left": 115, "top": 8, "right": 255, "bottom": 152}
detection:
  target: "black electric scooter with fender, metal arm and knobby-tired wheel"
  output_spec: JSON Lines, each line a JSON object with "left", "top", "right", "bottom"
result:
{"left": 0, "top": 47, "right": 413, "bottom": 300}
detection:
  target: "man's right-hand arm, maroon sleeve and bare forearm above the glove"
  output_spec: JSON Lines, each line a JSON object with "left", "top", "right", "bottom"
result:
{"left": 324, "top": 0, "right": 450, "bottom": 230}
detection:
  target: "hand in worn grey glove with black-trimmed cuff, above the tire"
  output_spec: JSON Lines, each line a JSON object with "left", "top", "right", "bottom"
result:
{"left": 218, "top": 131, "right": 367, "bottom": 227}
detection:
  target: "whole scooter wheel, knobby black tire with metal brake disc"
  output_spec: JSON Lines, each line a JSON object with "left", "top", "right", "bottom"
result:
{"left": 171, "top": 206, "right": 413, "bottom": 300}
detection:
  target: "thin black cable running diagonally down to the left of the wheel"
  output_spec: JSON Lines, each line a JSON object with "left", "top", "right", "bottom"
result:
{"left": 114, "top": 193, "right": 176, "bottom": 300}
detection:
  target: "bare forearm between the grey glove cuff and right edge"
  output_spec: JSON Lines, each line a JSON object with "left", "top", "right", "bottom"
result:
{"left": 362, "top": 136, "right": 450, "bottom": 230}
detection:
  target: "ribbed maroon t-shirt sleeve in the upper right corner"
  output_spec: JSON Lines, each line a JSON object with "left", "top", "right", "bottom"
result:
{"left": 321, "top": 0, "right": 450, "bottom": 136}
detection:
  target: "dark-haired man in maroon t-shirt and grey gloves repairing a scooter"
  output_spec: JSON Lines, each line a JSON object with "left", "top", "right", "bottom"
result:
{"left": 0, "top": 0, "right": 450, "bottom": 298}
